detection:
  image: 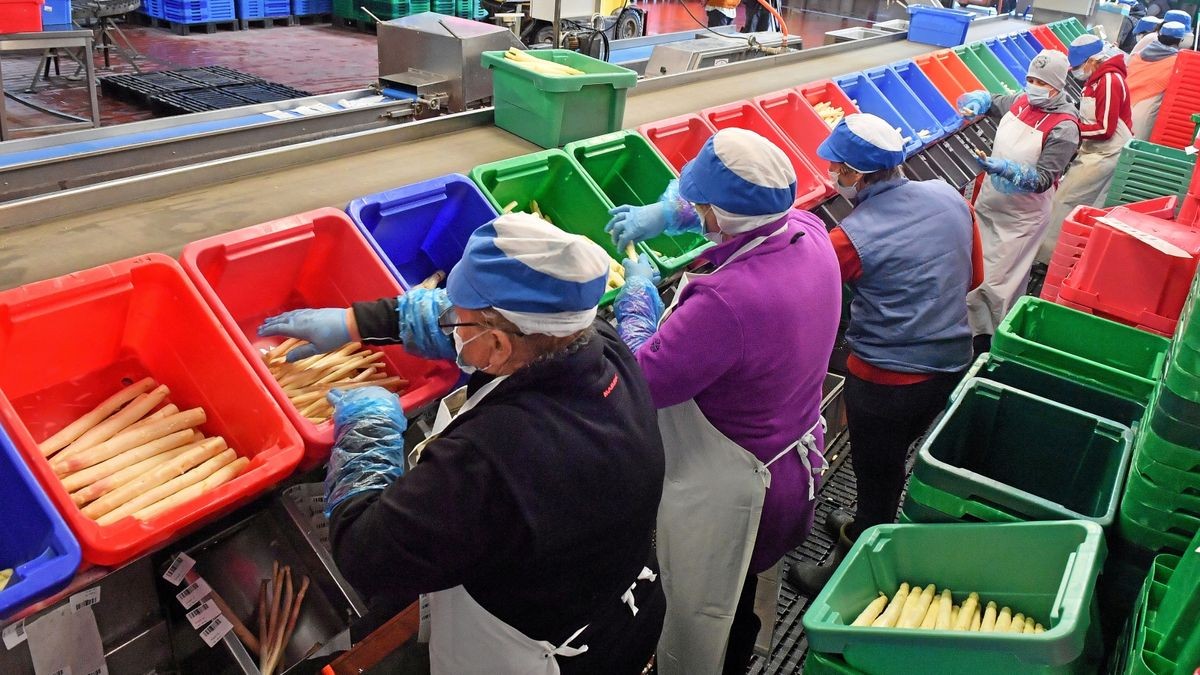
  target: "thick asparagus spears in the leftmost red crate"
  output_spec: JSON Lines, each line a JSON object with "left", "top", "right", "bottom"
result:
{"left": 38, "top": 377, "right": 250, "bottom": 525}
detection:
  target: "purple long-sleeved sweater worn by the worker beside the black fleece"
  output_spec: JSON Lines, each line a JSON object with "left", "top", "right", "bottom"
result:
{"left": 637, "top": 210, "right": 841, "bottom": 574}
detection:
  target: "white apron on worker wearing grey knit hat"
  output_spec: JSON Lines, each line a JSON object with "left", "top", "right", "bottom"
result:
{"left": 967, "top": 104, "right": 1054, "bottom": 335}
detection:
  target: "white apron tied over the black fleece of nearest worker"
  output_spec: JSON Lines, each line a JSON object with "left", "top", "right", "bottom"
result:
{"left": 409, "top": 376, "right": 656, "bottom": 675}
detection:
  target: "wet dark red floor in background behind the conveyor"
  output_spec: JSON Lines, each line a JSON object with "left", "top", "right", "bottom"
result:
{"left": 4, "top": 0, "right": 904, "bottom": 135}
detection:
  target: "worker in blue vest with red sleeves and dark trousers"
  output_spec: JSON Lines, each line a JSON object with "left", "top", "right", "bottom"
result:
{"left": 788, "top": 114, "right": 983, "bottom": 596}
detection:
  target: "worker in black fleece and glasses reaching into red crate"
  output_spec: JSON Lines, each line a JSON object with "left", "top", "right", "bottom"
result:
{"left": 259, "top": 214, "right": 666, "bottom": 675}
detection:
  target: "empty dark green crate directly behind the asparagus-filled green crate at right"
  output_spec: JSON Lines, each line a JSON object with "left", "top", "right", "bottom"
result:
{"left": 913, "top": 380, "right": 1133, "bottom": 527}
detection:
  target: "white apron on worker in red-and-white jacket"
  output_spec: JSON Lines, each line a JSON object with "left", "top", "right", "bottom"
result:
{"left": 1037, "top": 84, "right": 1133, "bottom": 264}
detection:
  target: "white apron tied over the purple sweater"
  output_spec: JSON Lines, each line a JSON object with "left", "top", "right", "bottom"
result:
{"left": 658, "top": 226, "right": 824, "bottom": 675}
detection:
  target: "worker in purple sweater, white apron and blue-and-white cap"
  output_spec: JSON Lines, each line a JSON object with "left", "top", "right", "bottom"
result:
{"left": 608, "top": 129, "right": 841, "bottom": 675}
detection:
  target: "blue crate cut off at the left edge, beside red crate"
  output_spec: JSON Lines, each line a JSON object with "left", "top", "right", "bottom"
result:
{"left": 0, "top": 429, "right": 80, "bottom": 619}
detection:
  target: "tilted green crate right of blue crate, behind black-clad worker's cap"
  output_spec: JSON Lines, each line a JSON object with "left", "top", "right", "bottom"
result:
{"left": 470, "top": 150, "right": 624, "bottom": 305}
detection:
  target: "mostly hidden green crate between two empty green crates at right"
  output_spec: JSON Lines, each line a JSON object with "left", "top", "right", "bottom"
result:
{"left": 947, "top": 352, "right": 1146, "bottom": 428}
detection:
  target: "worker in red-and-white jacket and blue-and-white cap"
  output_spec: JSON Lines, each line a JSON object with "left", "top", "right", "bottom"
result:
{"left": 1038, "top": 34, "right": 1133, "bottom": 264}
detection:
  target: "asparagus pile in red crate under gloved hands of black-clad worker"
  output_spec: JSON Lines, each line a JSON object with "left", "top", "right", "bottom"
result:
{"left": 263, "top": 338, "right": 408, "bottom": 424}
